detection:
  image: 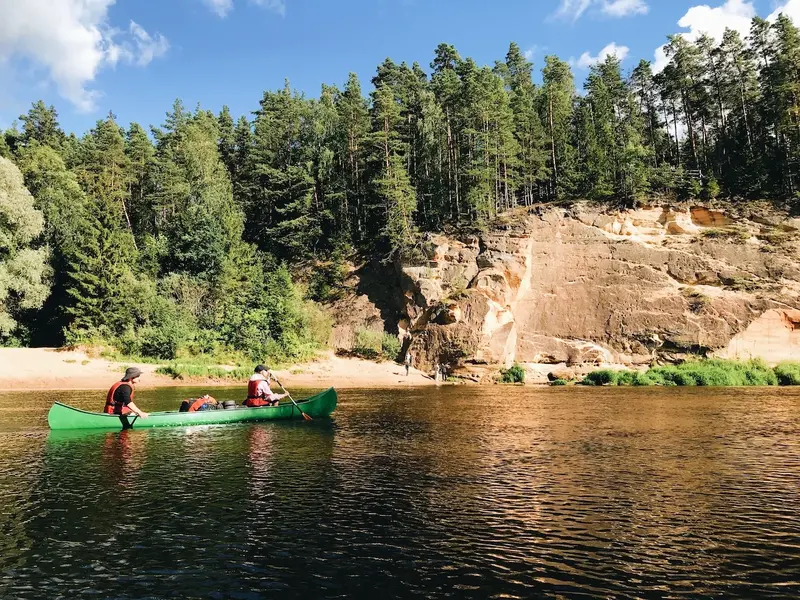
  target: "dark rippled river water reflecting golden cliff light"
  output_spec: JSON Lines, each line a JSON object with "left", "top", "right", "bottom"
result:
{"left": 0, "top": 387, "right": 800, "bottom": 599}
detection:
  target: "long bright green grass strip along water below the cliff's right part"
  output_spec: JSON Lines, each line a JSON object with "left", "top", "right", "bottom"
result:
{"left": 581, "top": 360, "right": 800, "bottom": 387}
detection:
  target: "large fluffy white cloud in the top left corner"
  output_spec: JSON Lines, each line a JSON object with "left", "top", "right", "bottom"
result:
{"left": 0, "top": 0, "right": 169, "bottom": 111}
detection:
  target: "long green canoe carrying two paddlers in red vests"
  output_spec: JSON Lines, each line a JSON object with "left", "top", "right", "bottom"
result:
{"left": 47, "top": 388, "right": 337, "bottom": 431}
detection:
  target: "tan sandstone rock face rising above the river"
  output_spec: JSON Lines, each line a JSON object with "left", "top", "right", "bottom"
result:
{"left": 328, "top": 204, "right": 800, "bottom": 380}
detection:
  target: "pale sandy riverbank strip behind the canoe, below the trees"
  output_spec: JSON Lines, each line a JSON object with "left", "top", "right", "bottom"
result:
{"left": 0, "top": 348, "right": 435, "bottom": 391}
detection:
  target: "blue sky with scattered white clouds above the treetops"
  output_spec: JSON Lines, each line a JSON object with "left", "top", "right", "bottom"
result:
{"left": 0, "top": 0, "right": 800, "bottom": 133}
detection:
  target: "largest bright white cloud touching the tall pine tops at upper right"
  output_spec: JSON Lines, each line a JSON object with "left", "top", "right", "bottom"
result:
{"left": 653, "top": 0, "right": 752, "bottom": 73}
